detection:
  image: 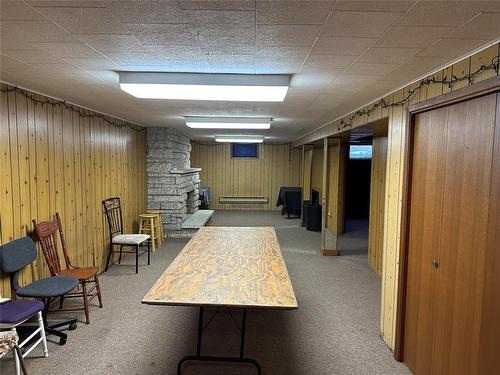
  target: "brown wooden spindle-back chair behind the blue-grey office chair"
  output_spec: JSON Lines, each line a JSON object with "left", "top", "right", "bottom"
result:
{"left": 33, "top": 213, "right": 102, "bottom": 324}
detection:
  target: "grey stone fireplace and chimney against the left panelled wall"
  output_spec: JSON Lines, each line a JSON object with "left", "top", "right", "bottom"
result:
{"left": 146, "top": 128, "right": 201, "bottom": 237}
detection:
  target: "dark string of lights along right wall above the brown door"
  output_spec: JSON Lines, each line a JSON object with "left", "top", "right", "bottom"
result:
{"left": 337, "top": 56, "right": 500, "bottom": 131}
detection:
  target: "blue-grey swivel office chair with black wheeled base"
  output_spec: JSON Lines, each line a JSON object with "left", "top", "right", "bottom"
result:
{"left": 0, "top": 237, "right": 79, "bottom": 345}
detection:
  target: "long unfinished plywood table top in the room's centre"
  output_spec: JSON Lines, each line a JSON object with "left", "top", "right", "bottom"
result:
{"left": 142, "top": 227, "right": 298, "bottom": 309}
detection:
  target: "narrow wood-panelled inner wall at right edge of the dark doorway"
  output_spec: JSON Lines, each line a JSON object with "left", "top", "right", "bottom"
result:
{"left": 368, "top": 137, "right": 387, "bottom": 275}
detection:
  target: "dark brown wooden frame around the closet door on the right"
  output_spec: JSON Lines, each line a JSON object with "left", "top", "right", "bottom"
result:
{"left": 394, "top": 76, "right": 500, "bottom": 362}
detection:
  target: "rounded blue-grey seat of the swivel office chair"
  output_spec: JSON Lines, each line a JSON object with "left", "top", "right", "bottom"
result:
{"left": 16, "top": 276, "right": 79, "bottom": 298}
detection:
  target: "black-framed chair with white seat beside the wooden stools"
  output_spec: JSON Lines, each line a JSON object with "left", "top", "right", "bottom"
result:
{"left": 102, "top": 197, "right": 151, "bottom": 273}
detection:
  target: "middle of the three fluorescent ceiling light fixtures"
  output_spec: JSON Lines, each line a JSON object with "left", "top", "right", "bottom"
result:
{"left": 184, "top": 116, "right": 271, "bottom": 129}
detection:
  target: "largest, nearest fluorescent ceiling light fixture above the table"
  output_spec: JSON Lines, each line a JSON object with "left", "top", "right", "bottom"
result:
{"left": 119, "top": 72, "right": 290, "bottom": 102}
